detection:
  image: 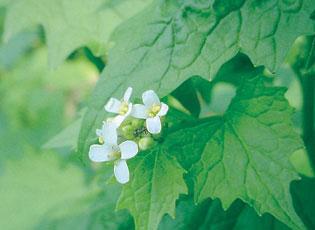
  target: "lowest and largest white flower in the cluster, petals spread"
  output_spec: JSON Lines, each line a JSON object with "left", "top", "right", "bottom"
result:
{"left": 89, "top": 122, "right": 138, "bottom": 184}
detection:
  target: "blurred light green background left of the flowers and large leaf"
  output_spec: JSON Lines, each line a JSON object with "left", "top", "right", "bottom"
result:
{"left": 0, "top": 6, "right": 131, "bottom": 229}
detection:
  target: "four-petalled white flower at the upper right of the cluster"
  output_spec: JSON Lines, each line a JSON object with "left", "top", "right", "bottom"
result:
{"left": 131, "top": 90, "right": 168, "bottom": 134}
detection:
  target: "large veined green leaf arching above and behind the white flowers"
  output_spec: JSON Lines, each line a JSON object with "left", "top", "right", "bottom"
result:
{"left": 78, "top": 0, "right": 315, "bottom": 159}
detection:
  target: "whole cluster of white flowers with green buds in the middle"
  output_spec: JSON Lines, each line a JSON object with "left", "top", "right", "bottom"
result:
{"left": 89, "top": 87, "right": 168, "bottom": 184}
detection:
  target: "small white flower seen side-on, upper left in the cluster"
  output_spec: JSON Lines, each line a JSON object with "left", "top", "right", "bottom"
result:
{"left": 105, "top": 87, "right": 132, "bottom": 126}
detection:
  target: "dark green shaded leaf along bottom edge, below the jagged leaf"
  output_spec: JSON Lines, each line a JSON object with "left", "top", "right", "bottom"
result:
{"left": 159, "top": 197, "right": 289, "bottom": 230}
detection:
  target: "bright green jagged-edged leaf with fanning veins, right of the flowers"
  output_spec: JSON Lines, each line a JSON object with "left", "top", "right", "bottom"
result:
{"left": 192, "top": 76, "right": 304, "bottom": 229}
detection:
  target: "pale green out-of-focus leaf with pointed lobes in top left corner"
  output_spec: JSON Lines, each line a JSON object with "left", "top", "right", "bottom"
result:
{"left": 4, "top": 0, "right": 150, "bottom": 67}
